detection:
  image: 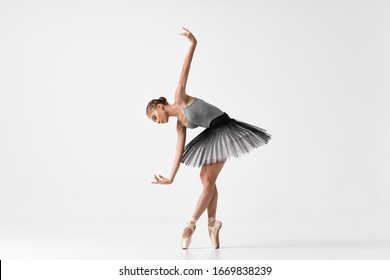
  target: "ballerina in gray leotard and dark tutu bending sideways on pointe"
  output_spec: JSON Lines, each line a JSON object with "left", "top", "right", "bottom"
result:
{"left": 146, "top": 27, "right": 271, "bottom": 249}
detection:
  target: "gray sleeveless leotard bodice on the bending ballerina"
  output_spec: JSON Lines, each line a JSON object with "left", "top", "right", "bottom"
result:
{"left": 178, "top": 98, "right": 223, "bottom": 128}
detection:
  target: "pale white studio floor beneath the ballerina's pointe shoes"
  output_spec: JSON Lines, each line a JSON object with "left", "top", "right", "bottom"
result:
{"left": 0, "top": 223, "right": 390, "bottom": 260}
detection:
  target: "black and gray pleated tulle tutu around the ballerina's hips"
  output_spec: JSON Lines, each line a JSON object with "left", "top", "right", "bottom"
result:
{"left": 181, "top": 113, "right": 271, "bottom": 167}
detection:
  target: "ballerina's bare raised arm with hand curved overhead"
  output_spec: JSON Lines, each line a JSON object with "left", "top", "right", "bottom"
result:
{"left": 175, "top": 27, "right": 197, "bottom": 101}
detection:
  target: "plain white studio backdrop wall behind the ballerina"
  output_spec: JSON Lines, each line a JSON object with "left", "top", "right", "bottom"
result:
{"left": 0, "top": 0, "right": 390, "bottom": 258}
